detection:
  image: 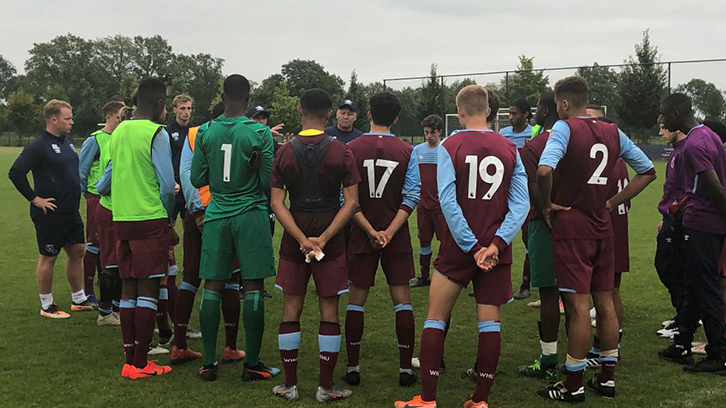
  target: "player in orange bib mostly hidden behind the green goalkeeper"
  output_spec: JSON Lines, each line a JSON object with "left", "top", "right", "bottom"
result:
{"left": 171, "top": 102, "right": 245, "bottom": 365}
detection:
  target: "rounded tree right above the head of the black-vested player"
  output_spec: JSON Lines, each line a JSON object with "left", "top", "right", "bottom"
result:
{"left": 282, "top": 59, "right": 345, "bottom": 104}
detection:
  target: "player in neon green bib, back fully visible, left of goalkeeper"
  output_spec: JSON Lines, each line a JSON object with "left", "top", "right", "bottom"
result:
{"left": 96, "top": 78, "right": 175, "bottom": 380}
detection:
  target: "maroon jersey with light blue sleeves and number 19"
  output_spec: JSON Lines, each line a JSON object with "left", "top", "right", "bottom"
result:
{"left": 435, "top": 130, "right": 529, "bottom": 272}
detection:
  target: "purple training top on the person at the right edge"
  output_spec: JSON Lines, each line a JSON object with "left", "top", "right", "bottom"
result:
{"left": 683, "top": 125, "right": 726, "bottom": 234}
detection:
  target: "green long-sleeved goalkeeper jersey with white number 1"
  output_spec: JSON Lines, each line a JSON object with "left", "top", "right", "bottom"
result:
{"left": 191, "top": 116, "right": 274, "bottom": 222}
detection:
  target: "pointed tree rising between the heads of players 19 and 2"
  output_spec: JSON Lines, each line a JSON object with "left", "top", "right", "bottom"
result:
{"left": 499, "top": 55, "right": 550, "bottom": 107}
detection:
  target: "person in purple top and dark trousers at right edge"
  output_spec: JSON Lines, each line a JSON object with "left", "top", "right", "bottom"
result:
{"left": 660, "top": 93, "right": 726, "bottom": 373}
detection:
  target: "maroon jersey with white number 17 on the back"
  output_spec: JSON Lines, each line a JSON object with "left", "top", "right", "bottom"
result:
{"left": 348, "top": 133, "right": 421, "bottom": 255}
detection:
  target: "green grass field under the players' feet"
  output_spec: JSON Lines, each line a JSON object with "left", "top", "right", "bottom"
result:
{"left": 0, "top": 148, "right": 726, "bottom": 408}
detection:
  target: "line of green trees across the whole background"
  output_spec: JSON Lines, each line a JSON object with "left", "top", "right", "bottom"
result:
{"left": 0, "top": 31, "right": 726, "bottom": 141}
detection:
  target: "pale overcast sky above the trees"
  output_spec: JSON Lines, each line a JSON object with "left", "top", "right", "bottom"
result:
{"left": 0, "top": 0, "right": 726, "bottom": 89}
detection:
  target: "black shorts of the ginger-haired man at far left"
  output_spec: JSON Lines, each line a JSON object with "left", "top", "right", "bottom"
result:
{"left": 31, "top": 211, "right": 86, "bottom": 256}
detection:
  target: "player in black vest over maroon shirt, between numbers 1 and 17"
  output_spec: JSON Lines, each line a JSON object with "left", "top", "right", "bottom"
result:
{"left": 271, "top": 89, "right": 360, "bottom": 402}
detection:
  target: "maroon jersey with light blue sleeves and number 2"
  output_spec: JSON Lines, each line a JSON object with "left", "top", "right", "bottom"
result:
{"left": 539, "top": 117, "right": 655, "bottom": 240}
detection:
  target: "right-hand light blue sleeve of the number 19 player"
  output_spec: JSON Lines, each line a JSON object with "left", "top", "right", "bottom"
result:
{"left": 495, "top": 152, "right": 529, "bottom": 244}
